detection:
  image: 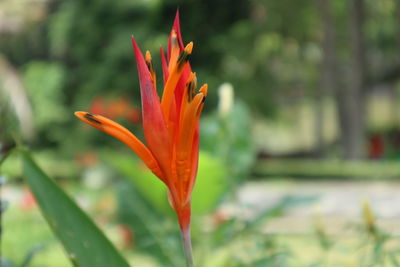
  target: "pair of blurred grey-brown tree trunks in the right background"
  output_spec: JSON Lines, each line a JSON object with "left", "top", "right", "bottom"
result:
{"left": 318, "top": 0, "right": 368, "bottom": 159}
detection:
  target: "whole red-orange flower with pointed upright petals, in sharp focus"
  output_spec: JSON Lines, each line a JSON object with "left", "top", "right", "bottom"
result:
{"left": 75, "top": 12, "right": 207, "bottom": 266}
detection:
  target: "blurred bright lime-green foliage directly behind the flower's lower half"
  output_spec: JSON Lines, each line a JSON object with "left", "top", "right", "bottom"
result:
{"left": 105, "top": 152, "right": 230, "bottom": 216}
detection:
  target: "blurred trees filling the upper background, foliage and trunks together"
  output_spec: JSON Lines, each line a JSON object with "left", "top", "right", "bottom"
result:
{"left": 0, "top": 0, "right": 400, "bottom": 158}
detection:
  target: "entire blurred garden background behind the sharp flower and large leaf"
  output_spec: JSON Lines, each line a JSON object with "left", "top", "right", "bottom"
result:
{"left": 0, "top": 0, "right": 400, "bottom": 267}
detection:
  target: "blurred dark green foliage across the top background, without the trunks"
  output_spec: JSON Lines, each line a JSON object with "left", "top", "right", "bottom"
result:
{"left": 0, "top": 0, "right": 400, "bottom": 157}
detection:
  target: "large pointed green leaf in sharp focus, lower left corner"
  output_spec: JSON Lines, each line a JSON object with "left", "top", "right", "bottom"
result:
{"left": 22, "top": 152, "right": 129, "bottom": 267}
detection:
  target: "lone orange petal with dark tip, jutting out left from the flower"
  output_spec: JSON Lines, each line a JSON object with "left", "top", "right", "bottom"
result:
{"left": 75, "top": 111, "right": 165, "bottom": 182}
